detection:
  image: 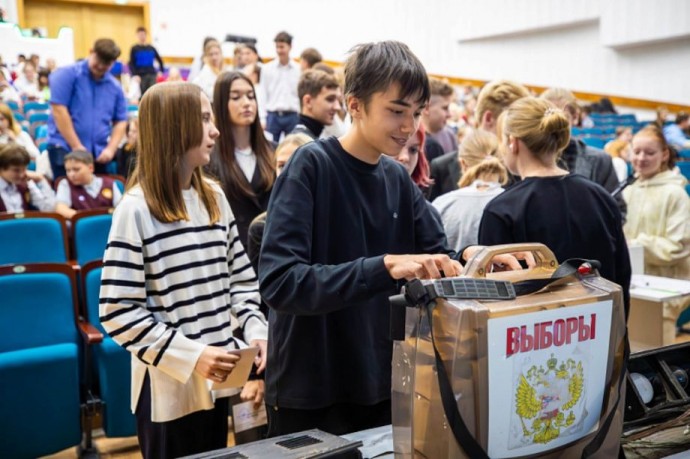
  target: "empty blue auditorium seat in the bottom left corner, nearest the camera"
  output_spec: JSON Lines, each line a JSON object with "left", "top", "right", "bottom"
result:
{"left": 0, "top": 264, "right": 95, "bottom": 459}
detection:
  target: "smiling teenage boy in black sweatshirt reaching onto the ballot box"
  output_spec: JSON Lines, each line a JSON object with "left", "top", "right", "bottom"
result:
{"left": 259, "top": 42, "right": 460, "bottom": 436}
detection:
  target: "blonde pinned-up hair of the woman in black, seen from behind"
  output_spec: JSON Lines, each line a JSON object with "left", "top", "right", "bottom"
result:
{"left": 503, "top": 97, "right": 570, "bottom": 163}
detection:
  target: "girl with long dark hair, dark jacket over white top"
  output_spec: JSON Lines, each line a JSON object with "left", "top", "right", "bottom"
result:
{"left": 209, "top": 72, "right": 276, "bottom": 247}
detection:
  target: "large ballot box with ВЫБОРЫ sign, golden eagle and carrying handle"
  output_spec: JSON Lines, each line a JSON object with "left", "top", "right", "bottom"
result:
{"left": 392, "top": 244, "right": 625, "bottom": 458}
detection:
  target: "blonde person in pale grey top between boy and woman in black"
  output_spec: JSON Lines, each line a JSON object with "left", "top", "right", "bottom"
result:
{"left": 433, "top": 130, "right": 508, "bottom": 251}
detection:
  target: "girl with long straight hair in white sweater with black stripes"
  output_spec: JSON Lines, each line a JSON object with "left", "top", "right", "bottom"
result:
{"left": 100, "top": 83, "right": 267, "bottom": 458}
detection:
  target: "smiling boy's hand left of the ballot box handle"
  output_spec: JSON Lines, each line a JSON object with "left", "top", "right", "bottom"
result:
{"left": 383, "top": 254, "right": 462, "bottom": 280}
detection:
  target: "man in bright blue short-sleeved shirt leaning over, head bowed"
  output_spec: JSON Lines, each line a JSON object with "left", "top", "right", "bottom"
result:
{"left": 48, "top": 38, "right": 127, "bottom": 178}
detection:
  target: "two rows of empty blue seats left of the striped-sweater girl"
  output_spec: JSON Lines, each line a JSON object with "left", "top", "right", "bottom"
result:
{"left": 0, "top": 209, "right": 136, "bottom": 458}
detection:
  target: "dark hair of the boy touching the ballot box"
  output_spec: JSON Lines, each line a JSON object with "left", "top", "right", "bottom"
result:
{"left": 345, "top": 41, "right": 430, "bottom": 105}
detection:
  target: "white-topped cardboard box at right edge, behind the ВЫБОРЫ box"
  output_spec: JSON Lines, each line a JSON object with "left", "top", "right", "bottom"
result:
{"left": 628, "top": 274, "right": 690, "bottom": 352}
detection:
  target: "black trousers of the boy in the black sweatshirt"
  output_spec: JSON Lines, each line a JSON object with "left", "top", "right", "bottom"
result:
{"left": 266, "top": 400, "right": 391, "bottom": 437}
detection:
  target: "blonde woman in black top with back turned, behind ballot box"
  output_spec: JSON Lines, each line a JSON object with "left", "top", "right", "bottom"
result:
{"left": 479, "top": 97, "right": 631, "bottom": 310}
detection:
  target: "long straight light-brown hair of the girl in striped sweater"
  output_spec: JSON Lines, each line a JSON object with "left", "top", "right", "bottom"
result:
{"left": 127, "top": 82, "right": 220, "bottom": 223}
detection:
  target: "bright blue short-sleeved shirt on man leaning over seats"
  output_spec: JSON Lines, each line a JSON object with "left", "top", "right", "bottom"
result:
{"left": 48, "top": 60, "right": 127, "bottom": 157}
